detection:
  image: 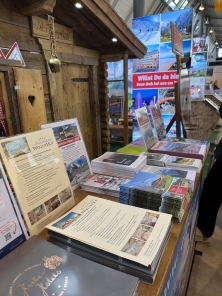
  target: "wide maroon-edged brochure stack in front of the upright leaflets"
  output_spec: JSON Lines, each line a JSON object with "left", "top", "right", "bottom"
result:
{"left": 149, "top": 141, "right": 207, "bottom": 160}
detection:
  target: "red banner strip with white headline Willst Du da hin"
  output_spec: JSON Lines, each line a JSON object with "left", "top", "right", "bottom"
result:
{"left": 133, "top": 71, "right": 179, "bottom": 89}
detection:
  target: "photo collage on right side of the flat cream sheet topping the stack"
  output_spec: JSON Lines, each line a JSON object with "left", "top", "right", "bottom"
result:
{"left": 122, "top": 212, "right": 159, "bottom": 256}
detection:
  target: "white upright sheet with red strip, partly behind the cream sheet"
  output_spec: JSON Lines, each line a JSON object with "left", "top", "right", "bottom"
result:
{"left": 41, "top": 118, "right": 93, "bottom": 190}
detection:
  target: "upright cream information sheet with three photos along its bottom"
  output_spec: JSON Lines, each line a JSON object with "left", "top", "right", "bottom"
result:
{"left": 0, "top": 129, "right": 75, "bottom": 235}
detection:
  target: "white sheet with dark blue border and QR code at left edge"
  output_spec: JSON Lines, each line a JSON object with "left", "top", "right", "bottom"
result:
{"left": 0, "top": 163, "right": 28, "bottom": 259}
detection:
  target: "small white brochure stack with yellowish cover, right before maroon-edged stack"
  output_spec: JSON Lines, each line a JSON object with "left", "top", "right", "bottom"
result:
{"left": 165, "top": 156, "right": 202, "bottom": 173}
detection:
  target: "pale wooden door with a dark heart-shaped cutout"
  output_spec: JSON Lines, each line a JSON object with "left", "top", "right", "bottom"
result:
{"left": 13, "top": 68, "right": 47, "bottom": 133}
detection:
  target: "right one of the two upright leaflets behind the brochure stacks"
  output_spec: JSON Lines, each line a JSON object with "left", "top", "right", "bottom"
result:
{"left": 149, "top": 104, "right": 166, "bottom": 141}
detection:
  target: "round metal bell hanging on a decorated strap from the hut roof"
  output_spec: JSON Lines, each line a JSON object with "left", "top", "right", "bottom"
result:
{"left": 48, "top": 15, "right": 61, "bottom": 73}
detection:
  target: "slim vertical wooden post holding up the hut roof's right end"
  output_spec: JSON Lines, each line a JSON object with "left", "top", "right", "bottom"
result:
{"left": 123, "top": 53, "right": 129, "bottom": 146}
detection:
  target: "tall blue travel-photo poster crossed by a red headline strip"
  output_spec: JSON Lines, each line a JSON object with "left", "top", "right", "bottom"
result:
{"left": 132, "top": 8, "right": 193, "bottom": 136}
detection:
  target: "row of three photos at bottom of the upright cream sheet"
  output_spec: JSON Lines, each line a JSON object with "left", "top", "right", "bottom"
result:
{"left": 27, "top": 187, "right": 72, "bottom": 225}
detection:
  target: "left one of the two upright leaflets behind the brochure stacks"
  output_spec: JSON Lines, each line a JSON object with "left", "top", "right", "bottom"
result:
{"left": 135, "top": 107, "right": 155, "bottom": 150}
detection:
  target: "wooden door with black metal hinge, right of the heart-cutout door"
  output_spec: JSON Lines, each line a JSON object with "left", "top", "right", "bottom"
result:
{"left": 56, "top": 64, "right": 94, "bottom": 159}
